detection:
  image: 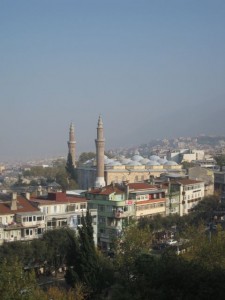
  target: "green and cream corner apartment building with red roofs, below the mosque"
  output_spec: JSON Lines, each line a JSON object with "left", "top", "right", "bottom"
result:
{"left": 85, "top": 183, "right": 165, "bottom": 250}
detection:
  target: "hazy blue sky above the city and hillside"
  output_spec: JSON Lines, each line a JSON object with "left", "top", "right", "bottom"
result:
{"left": 0, "top": 0, "right": 225, "bottom": 162}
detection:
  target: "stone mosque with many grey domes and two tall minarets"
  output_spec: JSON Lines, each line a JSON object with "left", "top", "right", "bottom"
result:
{"left": 68, "top": 116, "right": 183, "bottom": 189}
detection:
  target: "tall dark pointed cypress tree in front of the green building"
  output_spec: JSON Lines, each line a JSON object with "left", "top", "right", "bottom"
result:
{"left": 65, "top": 212, "right": 113, "bottom": 297}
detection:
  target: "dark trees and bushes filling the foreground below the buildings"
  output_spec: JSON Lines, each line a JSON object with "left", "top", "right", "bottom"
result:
{"left": 0, "top": 197, "right": 225, "bottom": 300}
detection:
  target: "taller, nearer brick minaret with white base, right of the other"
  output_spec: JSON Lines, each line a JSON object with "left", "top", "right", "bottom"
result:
{"left": 95, "top": 116, "right": 105, "bottom": 187}
